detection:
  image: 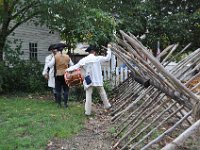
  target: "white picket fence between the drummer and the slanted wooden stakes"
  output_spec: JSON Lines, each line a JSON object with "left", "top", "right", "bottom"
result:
{"left": 102, "top": 67, "right": 128, "bottom": 88}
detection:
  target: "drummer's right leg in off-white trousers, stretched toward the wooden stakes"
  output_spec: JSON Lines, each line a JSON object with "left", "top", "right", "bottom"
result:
{"left": 97, "top": 86, "right": 111, "bottom": 109}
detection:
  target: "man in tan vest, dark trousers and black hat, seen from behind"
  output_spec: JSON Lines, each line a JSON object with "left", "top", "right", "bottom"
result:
{"left": 48, "top": 43, "right": 73, "bottom": 108}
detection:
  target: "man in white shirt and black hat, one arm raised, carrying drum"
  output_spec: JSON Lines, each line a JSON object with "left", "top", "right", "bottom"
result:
{"left": 66, "top": 44, "right": 111, "bottom": 115}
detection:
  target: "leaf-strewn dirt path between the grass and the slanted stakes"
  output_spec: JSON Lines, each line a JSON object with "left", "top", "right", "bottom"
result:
{"left": 46, "top": 105, "right": 113, "bottom": 150}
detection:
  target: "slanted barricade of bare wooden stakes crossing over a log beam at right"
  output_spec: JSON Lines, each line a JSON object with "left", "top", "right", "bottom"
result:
{"left": 111, "top": 31, "right": 200, "bottom": 150}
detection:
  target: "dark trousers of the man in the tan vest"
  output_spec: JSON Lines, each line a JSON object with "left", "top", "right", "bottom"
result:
{"left": 55, "top": 75, "right": 69, "bottom": 105}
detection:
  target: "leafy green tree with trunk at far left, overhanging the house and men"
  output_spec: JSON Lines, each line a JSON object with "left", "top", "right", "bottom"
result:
{"left": 0, "top": 0, "right": 116, "bottom": 60}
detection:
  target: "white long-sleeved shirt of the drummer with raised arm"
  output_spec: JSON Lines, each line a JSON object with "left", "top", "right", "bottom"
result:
{"left": 66, "top": 48, "right": 111, "bottom": 86}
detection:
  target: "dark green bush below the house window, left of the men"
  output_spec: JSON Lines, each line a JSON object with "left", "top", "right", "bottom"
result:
{"left": 0, "top": 60, "right": 47, "bottom": 93}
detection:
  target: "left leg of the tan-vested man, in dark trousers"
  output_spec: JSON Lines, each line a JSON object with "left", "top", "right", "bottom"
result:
{"left": 55, "top": 76, "right": 62, "bottom": 106}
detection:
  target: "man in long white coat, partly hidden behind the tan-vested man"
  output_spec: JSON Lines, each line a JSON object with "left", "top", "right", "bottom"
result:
{"left": 42, "top": 44, "right": 56, "bottom": 101}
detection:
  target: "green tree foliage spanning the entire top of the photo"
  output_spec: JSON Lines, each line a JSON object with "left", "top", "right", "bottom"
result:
{"left": 0, "top": 0, "right": 200, "bottom": 60}
